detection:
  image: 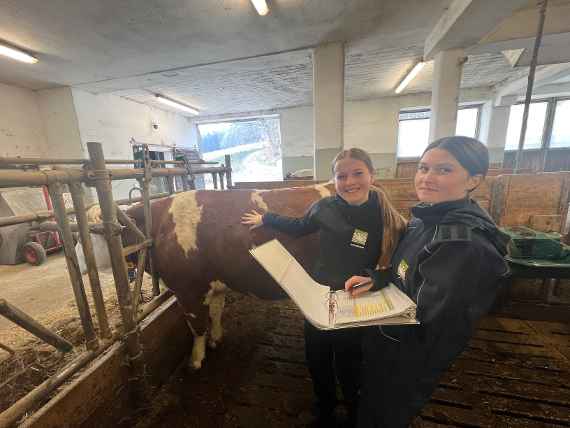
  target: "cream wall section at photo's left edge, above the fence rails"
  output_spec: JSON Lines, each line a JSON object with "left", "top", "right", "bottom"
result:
{"left": 0, "top": 83, "right": 47, "bottom": 157}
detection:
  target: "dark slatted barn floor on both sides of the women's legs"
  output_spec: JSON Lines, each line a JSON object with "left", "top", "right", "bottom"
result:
{"left": 121, "top": 295, "right": 570, "bottom": 428}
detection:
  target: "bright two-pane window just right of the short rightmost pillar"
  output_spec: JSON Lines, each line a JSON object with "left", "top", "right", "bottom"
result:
{"left": 505, "top": 101, "right": 548, "bottom": 150}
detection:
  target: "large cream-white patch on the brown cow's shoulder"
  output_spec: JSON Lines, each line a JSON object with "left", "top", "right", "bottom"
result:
{"left": 168, "top": 192, "right": 203, "bottom": 255}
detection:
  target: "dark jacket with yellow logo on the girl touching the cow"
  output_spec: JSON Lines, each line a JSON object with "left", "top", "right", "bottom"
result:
{"left": 263, "top": 192, "right": 383, "bottom": 290}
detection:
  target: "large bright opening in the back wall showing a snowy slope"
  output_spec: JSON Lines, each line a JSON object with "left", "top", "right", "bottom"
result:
{"left": 198, "top": 116, "right": 283, "bottom": 187}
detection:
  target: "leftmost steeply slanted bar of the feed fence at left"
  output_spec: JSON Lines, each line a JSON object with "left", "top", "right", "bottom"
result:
{"left": 48, "top": 181, "right": 99, "bottom": 350}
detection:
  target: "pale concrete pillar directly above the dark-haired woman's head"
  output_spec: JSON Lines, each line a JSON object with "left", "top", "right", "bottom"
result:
{"left": 429, "top": 49, "right": 465, "bottom": 142}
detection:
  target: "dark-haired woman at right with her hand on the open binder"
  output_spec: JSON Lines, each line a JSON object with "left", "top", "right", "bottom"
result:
{"left": 345, "top": 137, "right": 509, "bottom": 428}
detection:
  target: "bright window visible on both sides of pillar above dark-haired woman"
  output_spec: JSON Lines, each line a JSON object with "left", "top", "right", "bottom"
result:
{"left": 398, "top": 106, "right": 480, "bottom": 158}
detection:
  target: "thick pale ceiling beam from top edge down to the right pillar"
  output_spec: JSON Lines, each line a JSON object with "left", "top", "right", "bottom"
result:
{"left": 424, "top": 0, "right": 528, "bottom": 60}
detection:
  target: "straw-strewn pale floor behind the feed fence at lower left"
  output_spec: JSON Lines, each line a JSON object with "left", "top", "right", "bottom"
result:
{"left": 0, "top": 254, "right": 151, "bottom": 411}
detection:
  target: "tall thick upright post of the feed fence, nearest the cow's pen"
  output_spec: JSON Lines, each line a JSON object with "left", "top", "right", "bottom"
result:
{"left": 87, "top": 143, "right": 148, "bottom": 404}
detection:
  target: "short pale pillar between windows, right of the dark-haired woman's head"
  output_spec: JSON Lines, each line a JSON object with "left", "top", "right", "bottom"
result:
{"left": 479, "top": 102, "right": 511, "bottom": 164}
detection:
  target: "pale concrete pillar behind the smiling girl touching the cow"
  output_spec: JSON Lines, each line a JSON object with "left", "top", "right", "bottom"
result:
{"left": 313, "top": 43, "right": 344, "bottom": 180}
